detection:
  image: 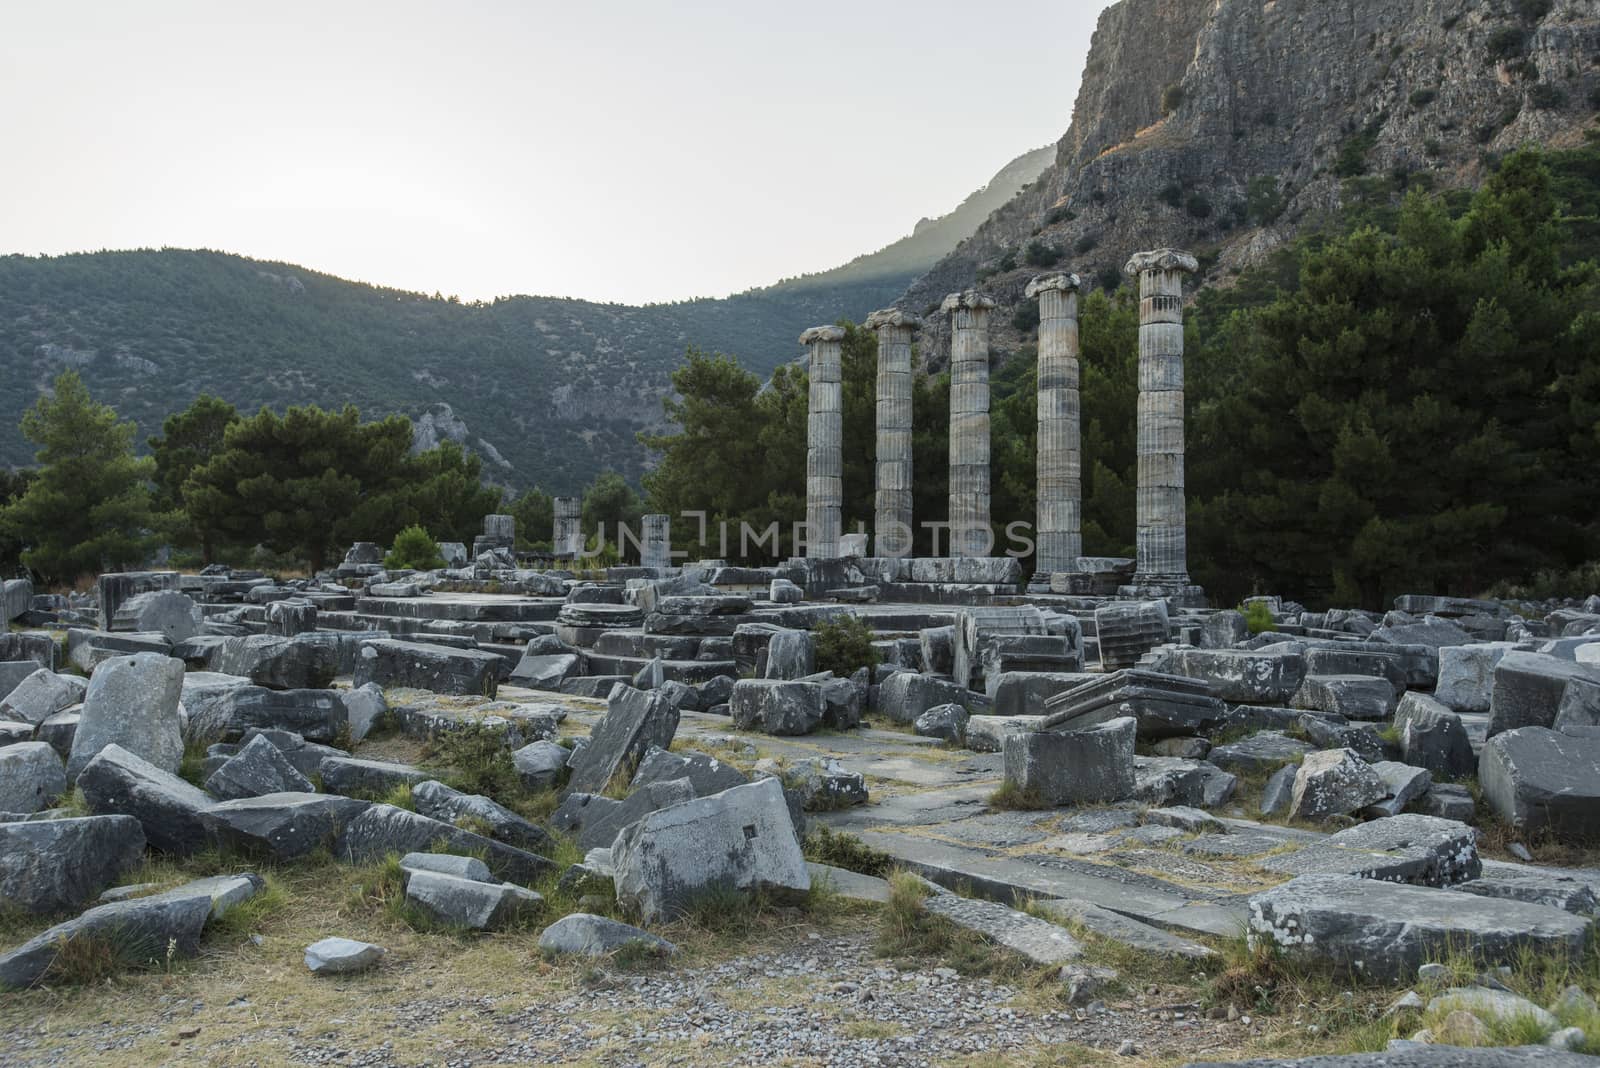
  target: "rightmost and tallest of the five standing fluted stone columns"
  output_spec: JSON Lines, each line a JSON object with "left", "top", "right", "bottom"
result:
{"left": 1125, "top": 248, "right": 1200, "bottom": 592}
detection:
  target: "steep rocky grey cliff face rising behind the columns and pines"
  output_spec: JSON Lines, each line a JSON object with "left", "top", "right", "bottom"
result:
{"left": 902, "top": 0, "right": 1600, "bottom": 365}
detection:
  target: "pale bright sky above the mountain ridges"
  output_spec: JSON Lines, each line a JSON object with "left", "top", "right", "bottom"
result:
{"left": 0, "top": 0, "right": 1107, "bottom": 304}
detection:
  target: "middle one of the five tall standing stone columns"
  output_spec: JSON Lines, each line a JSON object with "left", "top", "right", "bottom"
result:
{"left": 939, "top": 289, "right": 995, "bottom": 556}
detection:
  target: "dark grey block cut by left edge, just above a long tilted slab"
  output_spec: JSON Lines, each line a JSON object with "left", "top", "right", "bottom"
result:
{"left": 0, "top": 815, "right": 144, "bottom": 914}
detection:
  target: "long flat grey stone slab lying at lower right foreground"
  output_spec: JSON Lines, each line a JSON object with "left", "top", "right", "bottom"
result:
{"left": 1250, "top": 875, "right": 1589, "bottom": 982}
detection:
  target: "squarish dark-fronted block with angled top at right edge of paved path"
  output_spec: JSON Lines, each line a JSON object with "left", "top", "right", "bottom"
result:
{"left": 1002, "top": 716, "right": 1138, "bottom": 806}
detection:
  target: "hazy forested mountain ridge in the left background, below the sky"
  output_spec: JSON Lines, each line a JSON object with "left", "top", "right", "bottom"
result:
{"left": 0, "top": 147, "right": 1053, "bottom": 492}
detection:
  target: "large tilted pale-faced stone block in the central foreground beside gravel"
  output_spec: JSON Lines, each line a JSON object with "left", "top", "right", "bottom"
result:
{"left": 611, "top": 779, "right": 811, "bottom": 919}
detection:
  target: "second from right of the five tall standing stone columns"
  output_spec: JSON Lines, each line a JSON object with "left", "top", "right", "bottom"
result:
{"left": 1027, "top": 273, "right": 1083, "bottom": 576}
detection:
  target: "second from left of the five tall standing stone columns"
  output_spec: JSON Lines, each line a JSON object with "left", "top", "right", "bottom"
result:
{"left": 867, "top": 309, "right": 922, "bottom": 556}
